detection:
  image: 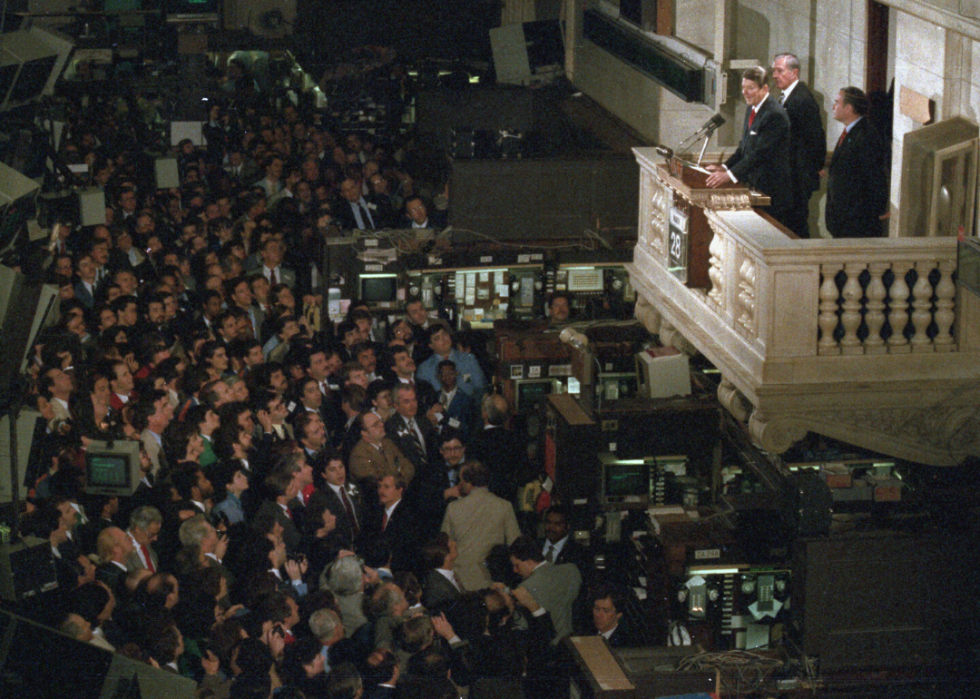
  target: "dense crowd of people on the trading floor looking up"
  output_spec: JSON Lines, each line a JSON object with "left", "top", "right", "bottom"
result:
{"left": 7, "top": 56, "right": 631, "bottom": 699}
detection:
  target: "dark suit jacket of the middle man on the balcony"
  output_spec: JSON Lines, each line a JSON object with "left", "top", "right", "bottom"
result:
{"left": 783, "top": 82, "right": 827, "bottom": 236}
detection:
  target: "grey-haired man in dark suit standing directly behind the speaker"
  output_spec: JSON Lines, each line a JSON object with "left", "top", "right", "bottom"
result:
{"left": 772, "top": 53, "right": 827, "bottom": 238}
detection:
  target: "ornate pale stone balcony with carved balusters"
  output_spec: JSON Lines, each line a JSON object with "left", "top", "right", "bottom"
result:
{"left": 630, "top": 149, "right": 980, "bottom": 465}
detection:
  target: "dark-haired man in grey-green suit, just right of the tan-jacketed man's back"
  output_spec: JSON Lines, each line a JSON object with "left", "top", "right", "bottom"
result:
{"left": 510, "top": 536, "right": 582, "bottom": 645}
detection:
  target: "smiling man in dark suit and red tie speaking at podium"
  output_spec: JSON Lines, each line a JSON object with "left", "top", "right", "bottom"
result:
{"left": 706, "top": 66, "right": 793, "bottom": 228}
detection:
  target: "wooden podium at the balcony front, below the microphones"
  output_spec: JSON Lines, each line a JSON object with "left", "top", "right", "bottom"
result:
{"left": 657, "top": 157, "right": 769, "bottom": 289}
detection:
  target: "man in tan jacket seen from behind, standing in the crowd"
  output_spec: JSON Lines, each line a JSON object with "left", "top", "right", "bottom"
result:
{"left": 442, "top": 461, "right": 520, "bottom": 590}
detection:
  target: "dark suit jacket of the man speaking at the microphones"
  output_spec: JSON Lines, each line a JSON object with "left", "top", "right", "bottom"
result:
{"left": 725, "top": 95, "right": 793, "bottom": 222}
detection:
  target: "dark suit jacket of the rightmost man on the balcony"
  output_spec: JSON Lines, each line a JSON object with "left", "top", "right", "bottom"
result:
{"left": 826, "top": 118, "right": 888, "bottom": 238}
